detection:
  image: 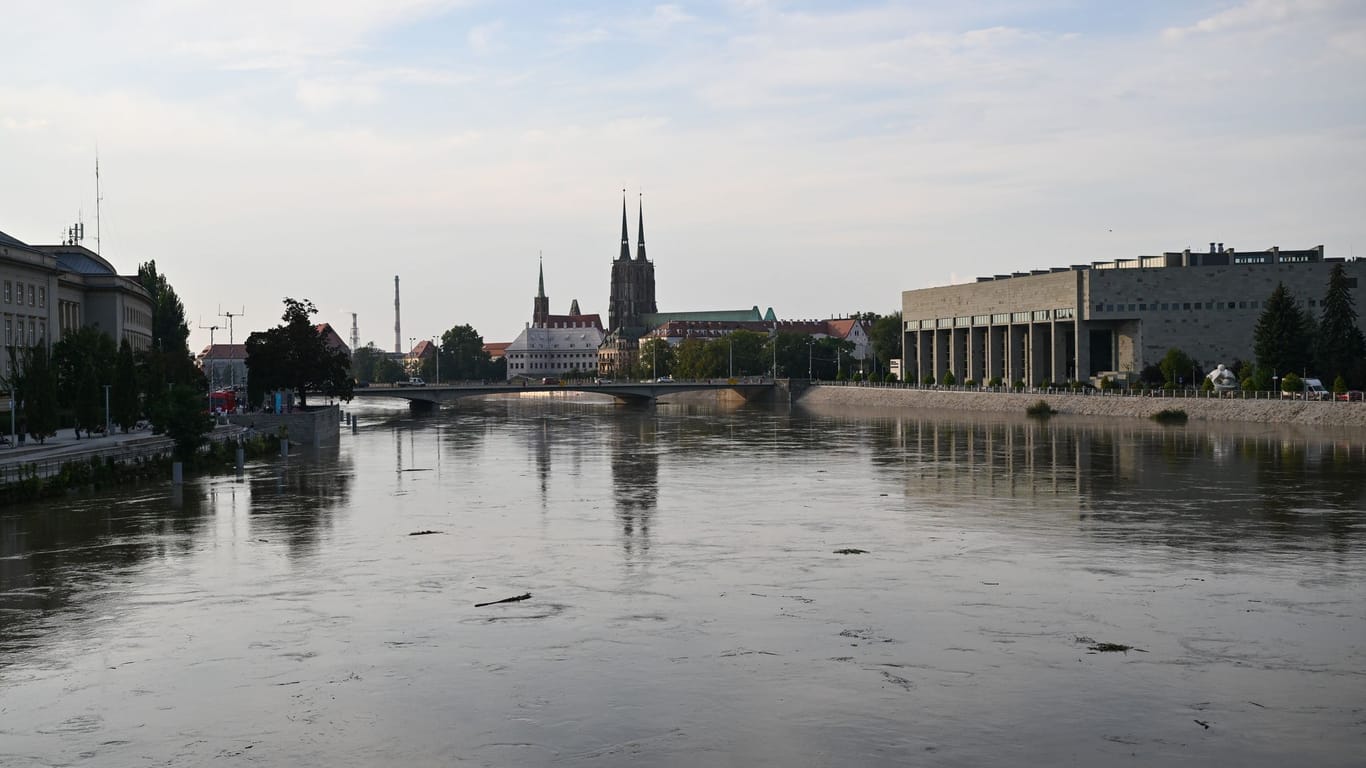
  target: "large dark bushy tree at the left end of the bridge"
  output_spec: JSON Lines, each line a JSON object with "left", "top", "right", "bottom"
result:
{"left": 246, "top": 298, "right": 354, "bottom": 406}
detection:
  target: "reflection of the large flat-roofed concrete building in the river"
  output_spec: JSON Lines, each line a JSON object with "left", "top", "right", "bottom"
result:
{"left": 872, "top": 418, "right": 1366, "bottom": 545}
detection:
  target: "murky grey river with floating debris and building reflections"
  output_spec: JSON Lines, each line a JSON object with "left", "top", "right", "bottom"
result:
{"left": 0, "top": 399, "right": 1366, "bottom": 767}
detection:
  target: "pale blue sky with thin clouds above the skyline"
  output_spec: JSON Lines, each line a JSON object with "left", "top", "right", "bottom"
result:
{"left": 0, "top": 0, "right": 1366, "bottom": 350}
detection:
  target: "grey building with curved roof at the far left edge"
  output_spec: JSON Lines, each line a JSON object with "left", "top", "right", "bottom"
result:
{"left": 0, "top": 226, "right": 152, "bottom": 377}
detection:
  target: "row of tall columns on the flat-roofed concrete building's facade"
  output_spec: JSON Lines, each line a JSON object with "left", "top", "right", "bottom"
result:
{"left": 904, "top": 321, "right": 1082, "bottom": 387}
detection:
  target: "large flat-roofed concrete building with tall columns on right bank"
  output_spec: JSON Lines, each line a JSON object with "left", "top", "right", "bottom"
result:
{"left": 902, "top": 243, "right": 1366, "bottom": 385}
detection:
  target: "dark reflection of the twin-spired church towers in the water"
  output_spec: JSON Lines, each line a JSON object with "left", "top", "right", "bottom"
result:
{"left": 612, "top": 414, "right": 660, "bottom": 559}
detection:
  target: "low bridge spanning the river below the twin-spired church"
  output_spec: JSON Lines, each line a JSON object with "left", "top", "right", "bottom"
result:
{"left": 354, "top": 377, "right": 779, "bottom": 407}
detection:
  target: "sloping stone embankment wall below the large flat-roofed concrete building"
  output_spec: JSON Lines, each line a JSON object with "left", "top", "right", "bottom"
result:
{"left": 795, "top": 384, "right": 1366, "bottom": 429}
